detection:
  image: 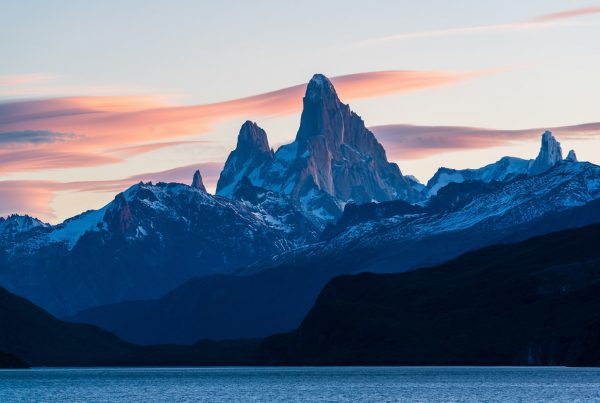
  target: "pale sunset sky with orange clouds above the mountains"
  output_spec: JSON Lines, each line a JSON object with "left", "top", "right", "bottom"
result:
{"left": 0, "top": 0, "right": 600, "bottom": 223}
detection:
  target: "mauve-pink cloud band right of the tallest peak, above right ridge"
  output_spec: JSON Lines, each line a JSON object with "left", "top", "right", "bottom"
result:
{"left": 370, "top": 123, "right": 600, "bottom": 160}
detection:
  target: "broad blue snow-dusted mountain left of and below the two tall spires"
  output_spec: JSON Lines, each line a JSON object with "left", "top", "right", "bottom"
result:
{"left": 0, "top": 170, "right": 319, "bottom": 315}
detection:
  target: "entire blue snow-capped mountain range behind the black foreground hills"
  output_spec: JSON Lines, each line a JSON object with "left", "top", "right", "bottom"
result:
{"left": 0, "top": 74, "right": 600, "bottom": 350}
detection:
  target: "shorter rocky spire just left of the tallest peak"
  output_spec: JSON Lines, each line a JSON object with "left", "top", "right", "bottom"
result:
{"left": 217, "top": 120, "right": 273, "bottom": 197}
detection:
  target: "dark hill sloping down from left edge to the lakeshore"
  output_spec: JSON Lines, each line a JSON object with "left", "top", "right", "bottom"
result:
{"left": 0, "top": 288, "right": 258, "bottom": 368}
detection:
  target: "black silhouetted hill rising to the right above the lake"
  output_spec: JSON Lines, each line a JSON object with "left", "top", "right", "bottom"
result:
{"left": 262, "top": 225, "right": 600, "bottom": 365}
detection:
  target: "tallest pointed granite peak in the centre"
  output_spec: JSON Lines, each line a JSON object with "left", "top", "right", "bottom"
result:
{"left": 292, "top": 74, "right": 416, "bottom": 203}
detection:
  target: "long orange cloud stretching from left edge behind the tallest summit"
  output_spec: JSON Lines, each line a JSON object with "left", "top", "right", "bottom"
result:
{"left": 0, "top": 71, "right": 482, "bottom": 172}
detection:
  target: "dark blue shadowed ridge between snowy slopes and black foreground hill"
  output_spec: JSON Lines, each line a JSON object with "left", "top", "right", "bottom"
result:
{"left": 69, "top": 192, "right": 600, "bottom": 344}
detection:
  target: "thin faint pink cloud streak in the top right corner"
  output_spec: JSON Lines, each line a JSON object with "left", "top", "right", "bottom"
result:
{"left": 358, "top": 6, "right": 600, "bottom": 45}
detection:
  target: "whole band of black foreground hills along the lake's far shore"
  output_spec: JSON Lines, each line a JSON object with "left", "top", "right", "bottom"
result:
{"left": 0, "top": 224, "right": 600, "bottom": 368}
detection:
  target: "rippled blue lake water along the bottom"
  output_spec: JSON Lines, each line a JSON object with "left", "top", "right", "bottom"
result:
{"left": 0, "top": 367, "right": 600, "bottom": 403}
